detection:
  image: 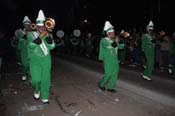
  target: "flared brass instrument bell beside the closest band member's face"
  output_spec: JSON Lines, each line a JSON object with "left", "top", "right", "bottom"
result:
{"left": 44, "top": 18, "right": 55, "bottom": 31}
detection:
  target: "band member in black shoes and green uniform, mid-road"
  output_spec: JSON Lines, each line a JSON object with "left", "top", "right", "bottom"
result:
{"left": 98, "top": 21, "right": 124, "bottom": 93}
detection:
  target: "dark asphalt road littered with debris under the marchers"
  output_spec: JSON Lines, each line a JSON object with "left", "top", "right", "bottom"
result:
{"left": 0, "top": 56, "right": 175, "bottom": 116}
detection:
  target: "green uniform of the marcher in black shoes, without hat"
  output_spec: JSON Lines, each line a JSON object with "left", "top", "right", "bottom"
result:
{"left": 99, "top": 37, "right": 124, "bottom": 89}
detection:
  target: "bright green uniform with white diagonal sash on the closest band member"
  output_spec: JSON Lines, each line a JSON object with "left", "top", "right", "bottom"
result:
{"left": 27, "top": 32, "right": 55, "bottom": 99}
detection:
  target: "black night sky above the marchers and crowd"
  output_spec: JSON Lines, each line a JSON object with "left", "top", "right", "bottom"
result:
{"left": 0, "top": 0, "right": 175, "bottom": 35}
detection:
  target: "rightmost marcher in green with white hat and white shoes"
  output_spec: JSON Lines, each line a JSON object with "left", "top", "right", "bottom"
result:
{"left": 142, "top": 21, "right": 155, "bottom": 81}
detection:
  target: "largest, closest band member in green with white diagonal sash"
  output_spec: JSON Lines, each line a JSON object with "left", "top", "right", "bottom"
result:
{"left": 28, "top": 10, "right": 55, "bottom": 104}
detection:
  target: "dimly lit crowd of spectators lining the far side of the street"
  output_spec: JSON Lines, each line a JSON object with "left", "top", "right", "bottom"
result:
{"left": 55, "top": 29, "right": 175, "bottom": 73}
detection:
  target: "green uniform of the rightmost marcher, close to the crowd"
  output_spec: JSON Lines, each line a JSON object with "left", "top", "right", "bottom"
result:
{"left": 142, "top": 34, "right": 154, "bottom": 78}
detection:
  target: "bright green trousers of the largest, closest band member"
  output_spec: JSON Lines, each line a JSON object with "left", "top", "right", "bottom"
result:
{"left": 30, "top": 56, "right": 51, "bottom": 99}
